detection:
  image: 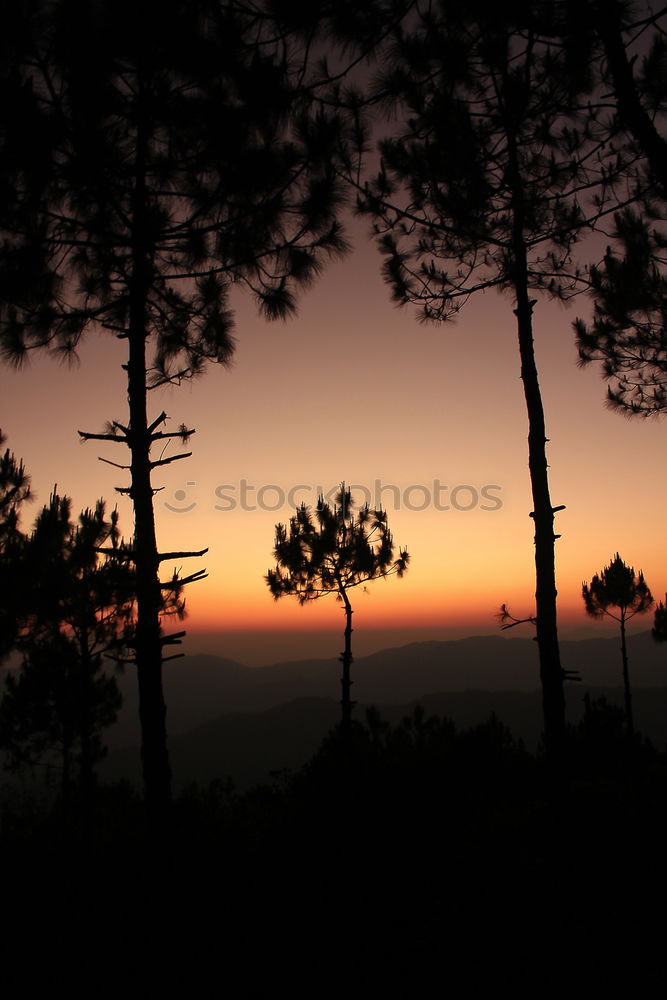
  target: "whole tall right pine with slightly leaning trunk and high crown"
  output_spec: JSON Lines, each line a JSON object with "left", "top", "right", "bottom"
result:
{"left": 360, "top": 0, "right": 616, "bottom": 752}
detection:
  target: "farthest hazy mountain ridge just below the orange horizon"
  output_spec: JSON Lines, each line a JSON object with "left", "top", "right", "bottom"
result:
{"left": 107, "top": 632, "right": 667, "bottom": 747}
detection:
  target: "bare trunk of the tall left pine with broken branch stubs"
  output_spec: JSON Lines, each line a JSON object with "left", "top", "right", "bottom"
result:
{"left": 127, "top": 101, "right": 171, "bottom": 822}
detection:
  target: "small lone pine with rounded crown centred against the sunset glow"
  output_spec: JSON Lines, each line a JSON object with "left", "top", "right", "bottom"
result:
{"left": 265, "top": 483, "right": 410, "bottom": 731}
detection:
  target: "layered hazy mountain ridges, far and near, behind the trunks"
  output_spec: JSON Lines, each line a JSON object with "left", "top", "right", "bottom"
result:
{"left": 103, "top": 632, "right": 667, "bottom": 787}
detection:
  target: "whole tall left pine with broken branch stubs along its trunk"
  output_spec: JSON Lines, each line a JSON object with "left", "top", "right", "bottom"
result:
{"left": 0, "top": 0, "right": 352, "bottom": 816}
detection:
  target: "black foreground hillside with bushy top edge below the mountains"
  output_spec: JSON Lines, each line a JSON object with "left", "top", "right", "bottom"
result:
{"left": 2, "top": 702, "right": 667, "bottom": 997}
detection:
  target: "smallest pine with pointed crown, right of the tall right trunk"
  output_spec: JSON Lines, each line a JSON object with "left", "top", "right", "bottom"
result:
{"left": 581, "top": 552, "right": 653, "bottom": 735}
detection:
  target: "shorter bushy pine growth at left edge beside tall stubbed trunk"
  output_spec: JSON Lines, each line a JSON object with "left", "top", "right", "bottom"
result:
{"left": 0, "top": 493, "right": 134, "bottom": 798}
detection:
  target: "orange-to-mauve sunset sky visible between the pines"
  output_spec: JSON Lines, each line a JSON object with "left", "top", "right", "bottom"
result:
{"left": 0, "top": 211, "right": 667, "bottom": 662}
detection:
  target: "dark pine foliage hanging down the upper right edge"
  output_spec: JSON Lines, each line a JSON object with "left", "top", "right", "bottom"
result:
{"left": 575, "top": 0, "right": 667, "bottom": 417}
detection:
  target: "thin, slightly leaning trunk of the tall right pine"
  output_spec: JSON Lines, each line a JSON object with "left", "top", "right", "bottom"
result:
{"left": 508, "top": 115, "right": 565, "bottom": 762}
